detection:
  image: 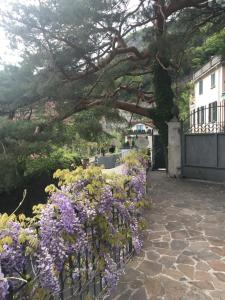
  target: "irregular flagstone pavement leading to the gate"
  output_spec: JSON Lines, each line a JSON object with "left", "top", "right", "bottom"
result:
{"left": 108, "top": 172, "right": 225, "bottom": 300}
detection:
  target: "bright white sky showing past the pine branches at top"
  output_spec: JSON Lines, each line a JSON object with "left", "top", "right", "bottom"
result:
{"left": 0, "top": 0, "right": 139, "bottom": 69}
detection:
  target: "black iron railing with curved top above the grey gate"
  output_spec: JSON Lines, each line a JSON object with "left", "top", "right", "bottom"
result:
{"left": 183, "top": 102, "right": 225, "bottom": 134}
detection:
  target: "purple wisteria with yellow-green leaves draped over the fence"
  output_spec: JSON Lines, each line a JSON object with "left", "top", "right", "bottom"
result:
{"left": 0, "top": 153, "right": 146, "bottom": 300}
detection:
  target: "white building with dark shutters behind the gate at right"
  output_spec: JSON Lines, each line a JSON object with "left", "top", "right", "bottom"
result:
{"left": 190, "top": 56, "right": 225, "bottom": 132}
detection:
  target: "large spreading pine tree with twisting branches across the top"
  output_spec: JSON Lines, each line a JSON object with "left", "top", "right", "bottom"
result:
{"left": 0, "top": 0, "right": 224, "bottom": 176}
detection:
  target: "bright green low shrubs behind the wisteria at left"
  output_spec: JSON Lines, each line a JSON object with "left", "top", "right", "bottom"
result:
{"left": 0, "top": 147, "right": 81, "bottom": 193}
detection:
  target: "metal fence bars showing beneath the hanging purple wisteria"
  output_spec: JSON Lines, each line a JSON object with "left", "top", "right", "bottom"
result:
{"left": 13, "top": 207, "right": 136, "bottom": 300}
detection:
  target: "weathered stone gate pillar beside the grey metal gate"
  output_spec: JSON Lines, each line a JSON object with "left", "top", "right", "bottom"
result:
{"left": 167, "top": 117, "right": 182, "bottom": 178}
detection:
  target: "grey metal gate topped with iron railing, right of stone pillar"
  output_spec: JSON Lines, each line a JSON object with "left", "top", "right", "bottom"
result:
{"left": 182, "top": 105, "right": 225, "bottom": 181}
